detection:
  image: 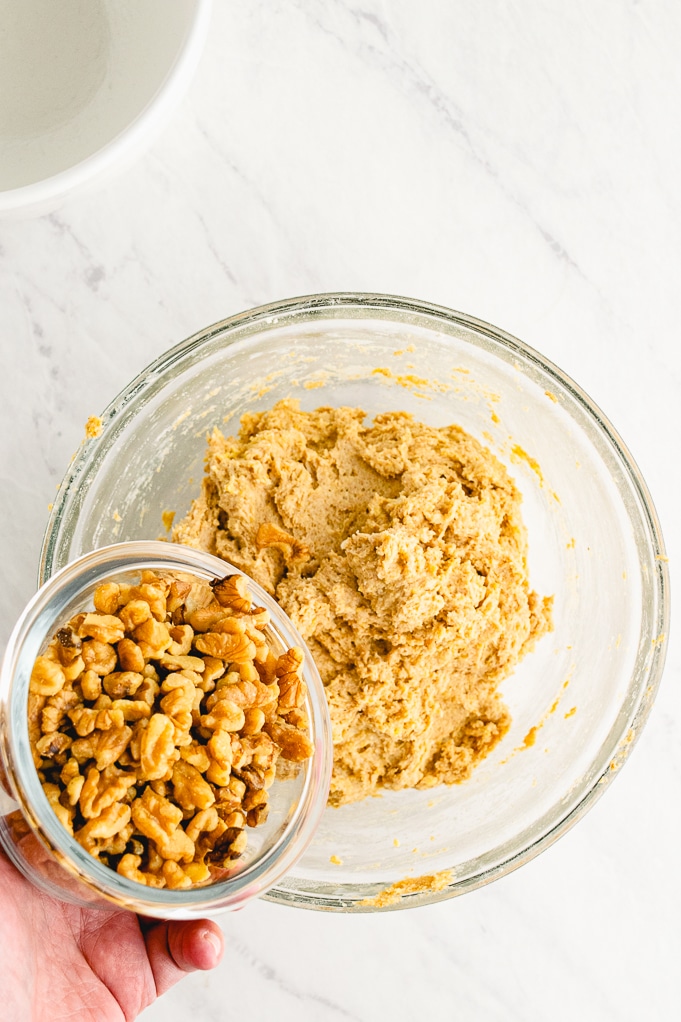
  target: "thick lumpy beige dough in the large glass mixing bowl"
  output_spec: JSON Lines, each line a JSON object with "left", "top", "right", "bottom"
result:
{"left": 173, "top": 401, "right": 551, "bottom": 805}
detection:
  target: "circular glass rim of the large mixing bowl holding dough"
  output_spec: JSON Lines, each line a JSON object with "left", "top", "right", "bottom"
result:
{"left": 39, "top": 291, "right": 670, "bottom": 912}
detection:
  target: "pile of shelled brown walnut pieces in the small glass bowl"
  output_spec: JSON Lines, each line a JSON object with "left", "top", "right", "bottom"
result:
{"left": 28, "top": 571, "right": 312, "bottom": 888}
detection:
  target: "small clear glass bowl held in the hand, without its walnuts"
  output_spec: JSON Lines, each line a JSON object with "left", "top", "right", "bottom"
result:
{"left": 0, "top": 542, "right": 332, "bottom": 919}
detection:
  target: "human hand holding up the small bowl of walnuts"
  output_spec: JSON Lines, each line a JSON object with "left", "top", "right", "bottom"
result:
{"left": 0, "top": 851, "right": 223, "bottom": 1022}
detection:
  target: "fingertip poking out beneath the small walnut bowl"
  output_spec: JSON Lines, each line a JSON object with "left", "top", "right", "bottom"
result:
{"left": 144, "top": 919, "right": 223, "bottom": 996}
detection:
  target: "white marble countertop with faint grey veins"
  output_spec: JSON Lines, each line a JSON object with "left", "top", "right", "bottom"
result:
{"left": 0, "top": 0, "right": 681, "bottom": 1022}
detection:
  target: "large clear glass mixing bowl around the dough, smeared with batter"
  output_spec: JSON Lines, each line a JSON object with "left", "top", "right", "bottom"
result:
{"left": 41, "top": 294, "right": 669, "bottom": 911}
